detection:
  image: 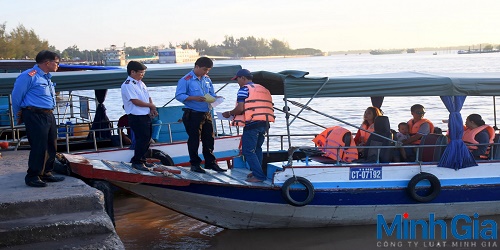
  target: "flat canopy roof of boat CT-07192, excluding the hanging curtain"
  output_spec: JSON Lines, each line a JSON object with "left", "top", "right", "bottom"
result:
{"left": 254, "top": 71, "right": 500, "bottom": 98}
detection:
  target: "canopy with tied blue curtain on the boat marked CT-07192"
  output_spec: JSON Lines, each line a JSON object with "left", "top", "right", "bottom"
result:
{"left": 254, "top": 71, "right": 500, "bottom": 170}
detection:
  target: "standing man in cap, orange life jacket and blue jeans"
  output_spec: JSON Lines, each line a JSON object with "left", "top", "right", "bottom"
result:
{"left": 222, "top": 69, "right": 274, "bottom": 182}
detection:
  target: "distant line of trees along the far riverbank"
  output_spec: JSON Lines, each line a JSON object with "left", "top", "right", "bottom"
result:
{"left": 0, "top": 23, "right": 322, "bottom": 61}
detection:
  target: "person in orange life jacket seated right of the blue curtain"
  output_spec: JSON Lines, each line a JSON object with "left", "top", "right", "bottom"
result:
{"left": 462, "top": 114, "right": 495, "bottom": 159}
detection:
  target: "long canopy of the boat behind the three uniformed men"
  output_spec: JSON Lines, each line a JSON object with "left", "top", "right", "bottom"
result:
{"left": 0, "top": 65, "right": 241, "bottom": 95}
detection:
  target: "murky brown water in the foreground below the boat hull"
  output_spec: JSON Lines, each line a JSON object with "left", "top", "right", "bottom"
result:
{"left": 115, "top": 193, "right": 500, "bottom": 250}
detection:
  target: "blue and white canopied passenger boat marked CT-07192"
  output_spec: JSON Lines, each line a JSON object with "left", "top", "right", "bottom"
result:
{"left": 60, "top": 71, "right": 500, "bottom": 230}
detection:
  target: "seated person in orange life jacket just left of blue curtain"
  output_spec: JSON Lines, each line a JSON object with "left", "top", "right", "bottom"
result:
{"left": 403, "top": 104, "right": 434, "bottom": 161}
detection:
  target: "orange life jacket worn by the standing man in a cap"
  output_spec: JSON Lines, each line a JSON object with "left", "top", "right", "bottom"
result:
{"left": 231, "top": 83, "right": 275, "bottom": 126}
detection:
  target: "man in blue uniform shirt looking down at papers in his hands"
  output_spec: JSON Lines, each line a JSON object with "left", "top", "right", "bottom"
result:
{"left": 175, "top": 56, "right": 226, "bottom": 173}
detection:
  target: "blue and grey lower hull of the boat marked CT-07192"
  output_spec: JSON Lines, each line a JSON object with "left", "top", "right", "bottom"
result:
{"left": 112, "top": 182, "right": 500, "bottom": 229}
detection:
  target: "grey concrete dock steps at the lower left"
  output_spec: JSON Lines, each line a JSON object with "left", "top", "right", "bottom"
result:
{"left": 0, "top": 150, "right": 124, "bottom": 249}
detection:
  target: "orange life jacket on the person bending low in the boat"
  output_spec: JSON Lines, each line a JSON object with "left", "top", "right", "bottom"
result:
{"left": 313, "top": 126, "right": 358, "bottom": 162}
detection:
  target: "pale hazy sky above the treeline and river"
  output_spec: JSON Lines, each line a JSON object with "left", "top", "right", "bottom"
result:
{"left": 0, "top": 0, "right": 500, "bottom": 51}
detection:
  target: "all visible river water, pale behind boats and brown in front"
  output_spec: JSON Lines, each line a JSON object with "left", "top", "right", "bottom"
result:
{"left": 103, "top": 51, "right": 500, "bottom": 249}
